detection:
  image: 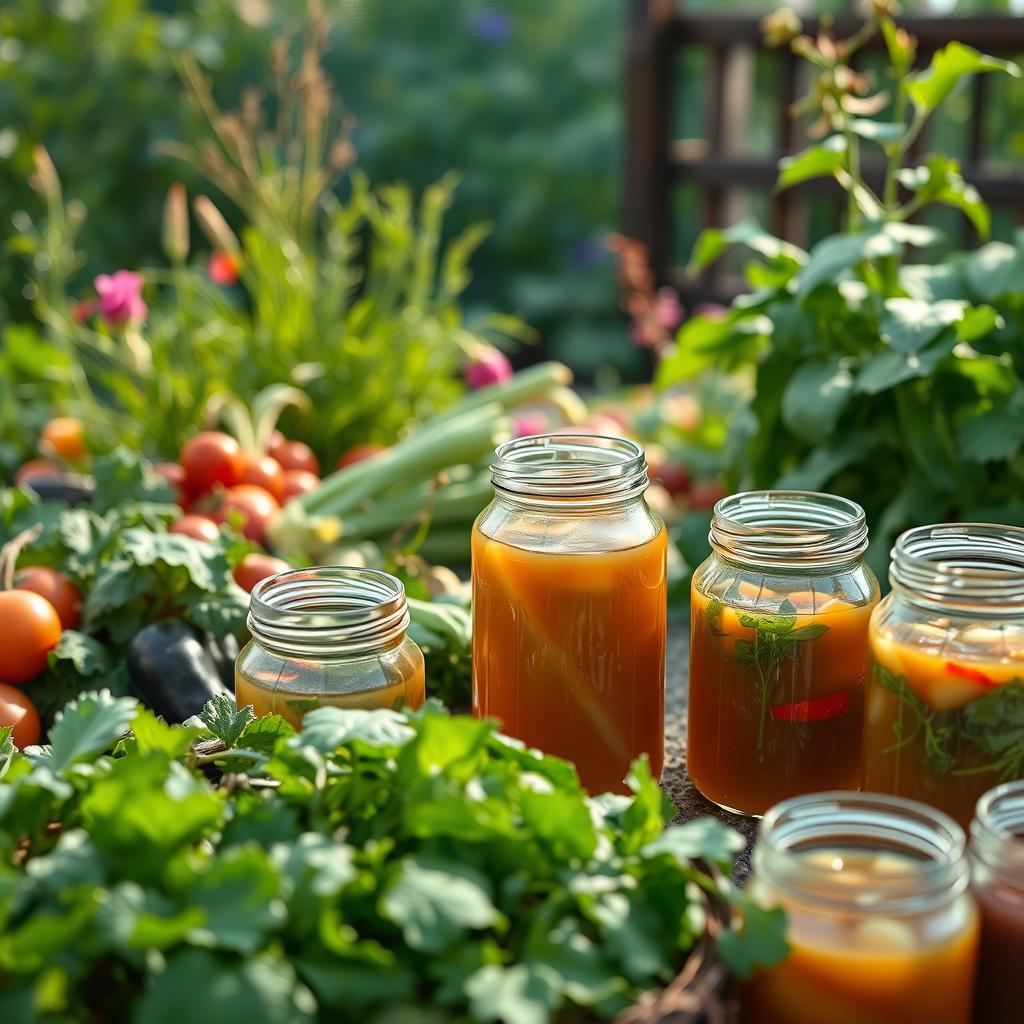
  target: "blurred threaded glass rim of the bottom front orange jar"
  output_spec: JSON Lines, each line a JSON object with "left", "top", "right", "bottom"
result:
{"left": 753, "top": 790, "right": 970, "bottom": 914}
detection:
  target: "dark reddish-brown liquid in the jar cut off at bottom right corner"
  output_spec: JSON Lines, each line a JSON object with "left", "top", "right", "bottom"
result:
{"left": 974, "top": 881, "right": 1024, "bottom": 1024}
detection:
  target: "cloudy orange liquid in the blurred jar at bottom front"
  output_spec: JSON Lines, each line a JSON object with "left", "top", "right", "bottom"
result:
{"left": 742, "top": 849, "right": 978, "bottom": 1024}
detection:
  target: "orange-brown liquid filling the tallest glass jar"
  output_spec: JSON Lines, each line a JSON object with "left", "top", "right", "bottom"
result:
{"left": 473, "top": 527, "right": 667, "bottom": 793}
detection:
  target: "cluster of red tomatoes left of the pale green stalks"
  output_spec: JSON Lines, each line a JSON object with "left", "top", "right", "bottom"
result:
{"left": 154, "top": 430, "right": 321, "bottom": 591}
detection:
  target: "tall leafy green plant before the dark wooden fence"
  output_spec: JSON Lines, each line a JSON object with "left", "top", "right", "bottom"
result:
{"left": 658, "top": 4, "right": 1024, "bottom": 570}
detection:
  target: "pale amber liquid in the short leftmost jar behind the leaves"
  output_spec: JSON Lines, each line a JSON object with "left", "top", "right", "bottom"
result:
{"left": 234, "top": 651, "right": 425, "bottom": 729}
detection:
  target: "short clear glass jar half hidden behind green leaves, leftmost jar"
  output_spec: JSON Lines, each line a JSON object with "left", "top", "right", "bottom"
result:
{"left": 234, "top": 565, "right": 424, "bottom": 727}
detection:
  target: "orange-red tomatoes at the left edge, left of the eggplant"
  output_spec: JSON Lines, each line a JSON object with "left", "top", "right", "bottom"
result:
{"left": 0, "top": 565, "right": 82, "bottom": 749}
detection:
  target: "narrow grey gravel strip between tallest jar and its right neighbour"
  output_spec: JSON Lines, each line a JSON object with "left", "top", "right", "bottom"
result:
{"left": 662, "top": 618, "right": 758, "bottom": 882}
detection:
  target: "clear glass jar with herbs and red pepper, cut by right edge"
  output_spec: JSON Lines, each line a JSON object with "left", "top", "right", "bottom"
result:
{"left": 864, "top": 523, "right": 1024, "bottom": 827}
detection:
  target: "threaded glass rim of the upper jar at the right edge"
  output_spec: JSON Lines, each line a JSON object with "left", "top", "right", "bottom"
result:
{"left": 889, "top": 522, "right": 1024, "bottom": 615}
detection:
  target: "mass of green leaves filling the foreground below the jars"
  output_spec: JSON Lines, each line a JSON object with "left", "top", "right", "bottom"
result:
{"left": 0, "top": 692, "right": 785, "bottom": 1024}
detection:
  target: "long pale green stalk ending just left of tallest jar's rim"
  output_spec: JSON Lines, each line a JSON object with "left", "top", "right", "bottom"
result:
{"left": 301, "top": 402, "right": 508, "bottom": 516}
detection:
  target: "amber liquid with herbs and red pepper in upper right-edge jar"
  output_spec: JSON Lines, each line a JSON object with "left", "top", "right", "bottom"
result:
{"left": 864, "top": 623, "right": 1024, "bottom": 826}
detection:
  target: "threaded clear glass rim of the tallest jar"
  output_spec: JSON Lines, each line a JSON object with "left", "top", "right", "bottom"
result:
{"left": 490, "top": 433, "right": 649, "bottom": 509}
